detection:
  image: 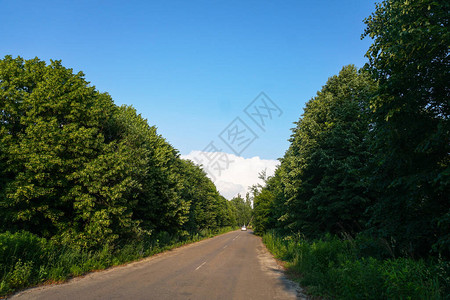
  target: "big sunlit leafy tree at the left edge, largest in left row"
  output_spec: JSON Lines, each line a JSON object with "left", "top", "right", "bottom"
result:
{"left": 0, "top": 56, "right": 146, "bottom": 247}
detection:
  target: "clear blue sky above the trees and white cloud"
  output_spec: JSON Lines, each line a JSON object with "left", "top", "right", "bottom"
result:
{"left": 0, "top": 0, "right": 374, "bottom": 159}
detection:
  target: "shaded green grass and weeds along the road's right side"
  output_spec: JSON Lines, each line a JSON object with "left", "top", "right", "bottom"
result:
{"left": 263, "top": 232, "right": 450, "bottom": 299}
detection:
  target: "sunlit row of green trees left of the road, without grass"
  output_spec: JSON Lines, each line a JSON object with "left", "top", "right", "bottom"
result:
{"left": 0, "top": 56, "right": 248, "bottom": 249}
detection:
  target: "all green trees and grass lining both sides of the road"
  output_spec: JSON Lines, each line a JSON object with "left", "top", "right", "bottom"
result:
{"left": 0, "top": 0, "right": 450, "bottom": 299}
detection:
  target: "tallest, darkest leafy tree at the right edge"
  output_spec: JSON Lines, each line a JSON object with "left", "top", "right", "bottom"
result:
{"left": 363, "top": 0, "right": 450, "bottom": 255}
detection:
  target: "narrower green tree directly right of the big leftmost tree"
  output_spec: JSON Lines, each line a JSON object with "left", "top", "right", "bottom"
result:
{"left": 115, "top": 106, "right": 189, "bottom": 233}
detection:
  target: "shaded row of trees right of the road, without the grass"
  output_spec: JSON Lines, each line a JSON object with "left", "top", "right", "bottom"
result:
{"left": 253, "top": 0, "right": 450, "bottom": 258}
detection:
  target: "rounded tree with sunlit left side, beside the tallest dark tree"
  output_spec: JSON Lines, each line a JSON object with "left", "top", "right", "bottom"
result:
{"left": 282, "top": 65, "right": 376, "bottom": 237}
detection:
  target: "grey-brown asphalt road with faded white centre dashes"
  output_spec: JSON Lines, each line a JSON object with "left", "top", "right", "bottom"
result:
{"left": 12, "top": 231, "right": 297, "bottom": 300}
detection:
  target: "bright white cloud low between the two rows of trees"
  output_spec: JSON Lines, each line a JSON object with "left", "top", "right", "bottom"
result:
{"left": 181, "top": 151, "right": 279, "bottom": 199}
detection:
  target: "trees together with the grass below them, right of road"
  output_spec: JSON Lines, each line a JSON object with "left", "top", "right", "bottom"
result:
{"left": 253, "top": 0, "right": 450, "bottom": 299}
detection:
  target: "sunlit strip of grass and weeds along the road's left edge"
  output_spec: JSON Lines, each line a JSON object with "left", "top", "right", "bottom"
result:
{"left": 0, "top": 227, "right": 237, "bottom": 298}
